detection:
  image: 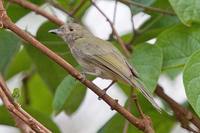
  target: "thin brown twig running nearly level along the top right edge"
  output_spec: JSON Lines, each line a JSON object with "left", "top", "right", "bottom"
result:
{"left": 119, "top": 0, "right": 176, "bottom": 16}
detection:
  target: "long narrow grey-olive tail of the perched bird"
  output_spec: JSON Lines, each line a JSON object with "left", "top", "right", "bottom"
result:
{"left": 130, "top": 77, "right": 161, "bottom": 112}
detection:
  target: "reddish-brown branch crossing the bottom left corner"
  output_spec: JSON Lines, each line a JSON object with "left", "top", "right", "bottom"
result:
{"left": 0, "top": 75, "right": 51, "bottom": 133}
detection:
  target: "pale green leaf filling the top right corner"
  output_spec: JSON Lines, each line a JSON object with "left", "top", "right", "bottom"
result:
{"left": 169, "top": 0, "right": 200, "bottom": 26}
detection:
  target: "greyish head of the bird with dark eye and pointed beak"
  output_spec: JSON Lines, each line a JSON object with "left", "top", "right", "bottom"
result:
{"left": 49, "top": 23, "right": 91, "bottom": 43}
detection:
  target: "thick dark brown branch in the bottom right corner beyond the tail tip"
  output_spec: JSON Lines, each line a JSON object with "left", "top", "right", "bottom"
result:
{"left": 155, "top": 86, "right": 200, "bottom": 132}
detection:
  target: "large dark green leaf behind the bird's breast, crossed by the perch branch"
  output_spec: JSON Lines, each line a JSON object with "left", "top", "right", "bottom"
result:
{"left": 25, "top": 22, "right": 76, "bottom": 91}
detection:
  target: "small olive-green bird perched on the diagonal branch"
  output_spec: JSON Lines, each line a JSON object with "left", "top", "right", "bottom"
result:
{"left": 49, "top": 23, "right": 160, "bottom": 110}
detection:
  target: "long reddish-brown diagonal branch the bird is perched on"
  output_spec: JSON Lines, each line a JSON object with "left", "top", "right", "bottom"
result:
{"left": 0, "top": 0, "right": 153, "bottom": 132}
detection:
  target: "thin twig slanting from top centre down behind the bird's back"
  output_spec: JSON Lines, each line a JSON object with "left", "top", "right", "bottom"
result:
{"left": 90, "top": 0, "right": 130, "bottom": 57}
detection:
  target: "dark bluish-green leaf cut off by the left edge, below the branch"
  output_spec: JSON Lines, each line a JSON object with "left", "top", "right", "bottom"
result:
{"left": 0, "top": 30, "right": 21, "bottom": 74}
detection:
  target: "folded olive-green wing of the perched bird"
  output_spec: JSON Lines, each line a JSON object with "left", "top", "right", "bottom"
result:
{"left": 76, "top": 38, "right": 135, "bottom": 80}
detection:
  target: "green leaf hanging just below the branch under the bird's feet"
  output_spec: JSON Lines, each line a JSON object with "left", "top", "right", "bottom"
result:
{"left": 53, "top": 75, "right": 86, "bottom": 114}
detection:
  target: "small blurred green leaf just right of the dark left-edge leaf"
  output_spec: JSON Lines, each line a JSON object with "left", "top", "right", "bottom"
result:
{"left": 5, "top": 48, "right": 32, "bottom": 79}
